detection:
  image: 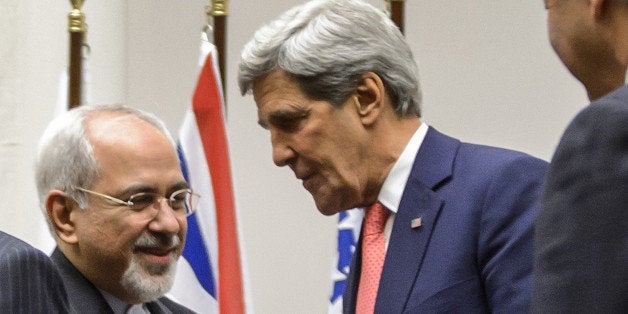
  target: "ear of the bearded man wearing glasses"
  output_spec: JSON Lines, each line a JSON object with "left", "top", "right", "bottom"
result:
{"left": 46, "top": 190, "right": 81, "bottom": 244}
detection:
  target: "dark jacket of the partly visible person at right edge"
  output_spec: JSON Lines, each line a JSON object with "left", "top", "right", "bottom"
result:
{"left": 533, "top": 86, "right": 628, "bottom": 313}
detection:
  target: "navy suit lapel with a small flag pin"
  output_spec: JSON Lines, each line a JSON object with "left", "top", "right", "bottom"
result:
{"left": 372, "top": 128, "right": 460, "bottom": 313}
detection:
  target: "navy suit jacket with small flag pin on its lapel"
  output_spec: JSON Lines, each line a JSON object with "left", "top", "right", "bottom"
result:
{"left": 343, "top": 128, "right": 547, "bottom": 313}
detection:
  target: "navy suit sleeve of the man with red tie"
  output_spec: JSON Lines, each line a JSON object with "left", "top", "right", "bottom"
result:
{"left": 477, "top": 155, "right": 547, "bottom": 313}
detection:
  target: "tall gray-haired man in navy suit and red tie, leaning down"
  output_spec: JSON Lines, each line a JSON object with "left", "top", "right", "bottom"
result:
{"left": 238, "top": 0, "right": 547, "bottom": 313}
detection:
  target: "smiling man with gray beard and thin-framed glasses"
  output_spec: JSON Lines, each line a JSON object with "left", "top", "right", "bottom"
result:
{"left": 35, "top": 105, "right": 198, "bottom": 313}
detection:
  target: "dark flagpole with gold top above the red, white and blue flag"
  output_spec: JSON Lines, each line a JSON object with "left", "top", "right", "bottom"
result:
{"left": 207, "top": 0, "right": 229, "bottom": 93}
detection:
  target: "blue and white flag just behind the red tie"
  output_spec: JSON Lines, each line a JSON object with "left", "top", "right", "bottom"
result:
{"left": 329, "top": 208, "right": 364, "bottom": 314}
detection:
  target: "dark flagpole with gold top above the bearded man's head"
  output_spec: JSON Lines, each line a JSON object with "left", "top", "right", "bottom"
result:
{"left": 68, "top": 0, "right": 86, "bottom": 109}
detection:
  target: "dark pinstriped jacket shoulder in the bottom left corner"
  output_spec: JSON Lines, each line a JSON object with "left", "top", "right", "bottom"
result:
{"left": 0, "top": 231, "right": 70, "bottom": 313}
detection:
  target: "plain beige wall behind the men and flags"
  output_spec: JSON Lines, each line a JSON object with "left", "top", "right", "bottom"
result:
{"left": 0, "top": 0, "right": 587, "bottom": 313}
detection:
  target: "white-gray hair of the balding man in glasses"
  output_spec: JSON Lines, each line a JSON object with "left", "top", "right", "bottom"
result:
{"left": 35, "top": 105, "right": 175, "bottom": 212}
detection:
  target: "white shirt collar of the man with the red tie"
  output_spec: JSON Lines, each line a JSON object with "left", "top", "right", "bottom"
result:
{"left": 377, "top": 123, "right": 428, "bottom": 213}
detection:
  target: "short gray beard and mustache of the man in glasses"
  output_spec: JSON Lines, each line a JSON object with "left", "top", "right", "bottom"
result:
{"left": 120, "top": 234, "right": 181, "bottom": 303}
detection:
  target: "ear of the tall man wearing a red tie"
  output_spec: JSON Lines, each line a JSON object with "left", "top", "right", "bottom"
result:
{"left": 352, "top": 72, "right": 386, "bottom": 125}
